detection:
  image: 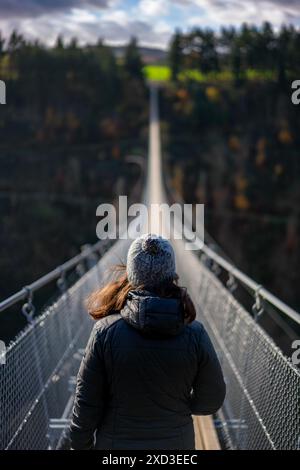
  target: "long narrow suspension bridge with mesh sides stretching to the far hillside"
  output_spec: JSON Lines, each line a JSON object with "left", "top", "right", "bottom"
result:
{"left": 0, "top": 86, "right": 300, "bottom": 450}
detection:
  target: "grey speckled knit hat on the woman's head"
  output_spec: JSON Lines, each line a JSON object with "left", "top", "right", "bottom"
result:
{"left": 127, "top": 233, "right": 177, "bottom": 289}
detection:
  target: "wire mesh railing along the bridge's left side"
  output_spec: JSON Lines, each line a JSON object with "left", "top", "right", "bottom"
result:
{"left": 0, "top": 237, "right": 128, "bottom": 449}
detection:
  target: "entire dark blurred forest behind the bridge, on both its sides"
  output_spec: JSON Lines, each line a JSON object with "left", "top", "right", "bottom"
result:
{"left": 0, "top": 23, "right": 300, "bottom": 338}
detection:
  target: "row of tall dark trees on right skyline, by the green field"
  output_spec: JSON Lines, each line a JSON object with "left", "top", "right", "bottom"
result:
{"left": 169, "top": 22, "right": 300, "bottom": 85}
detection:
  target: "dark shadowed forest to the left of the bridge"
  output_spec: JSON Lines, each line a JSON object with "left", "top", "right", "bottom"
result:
{"left": 0, "top": 32, "right": 148, "bottom": 314}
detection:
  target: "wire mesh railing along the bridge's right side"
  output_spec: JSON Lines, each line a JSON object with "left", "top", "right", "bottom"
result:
{"left": 176, "top": 242, "right": 300, "bottom": 450}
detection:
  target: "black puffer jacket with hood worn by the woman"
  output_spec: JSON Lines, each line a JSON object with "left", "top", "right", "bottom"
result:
{"left": 70, "top": 291, "right": 225, "bottom": 450}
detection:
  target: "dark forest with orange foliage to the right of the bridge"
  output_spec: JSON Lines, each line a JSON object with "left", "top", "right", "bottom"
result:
{"left": 162, "top": 23, "right": 300, "bottom": 308}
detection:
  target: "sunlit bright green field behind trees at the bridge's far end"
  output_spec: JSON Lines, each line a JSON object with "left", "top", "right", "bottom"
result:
{"left": 143, "top": 65, "right": 275, "bottom": 82}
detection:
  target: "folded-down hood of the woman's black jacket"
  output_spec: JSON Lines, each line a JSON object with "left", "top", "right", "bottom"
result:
{"left": 120, "top": 290, "right": 184, "bottom": 336}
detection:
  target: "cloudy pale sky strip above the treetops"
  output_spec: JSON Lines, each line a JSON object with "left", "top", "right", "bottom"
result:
{"left": 0, "top": 0, "right": 300, "bottom": 47}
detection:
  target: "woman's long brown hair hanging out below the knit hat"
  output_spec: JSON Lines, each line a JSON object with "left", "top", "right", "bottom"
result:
{"left": 86, "top": 265, "right": 196, "bottom": 323}
